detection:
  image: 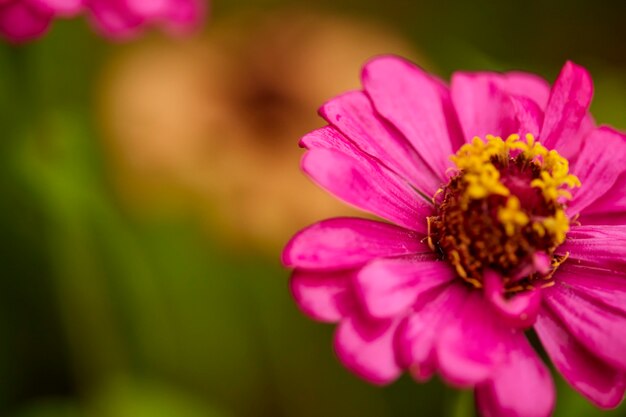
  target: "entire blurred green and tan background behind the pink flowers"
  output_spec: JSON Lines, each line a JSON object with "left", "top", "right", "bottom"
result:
{"left": 0, "top": 0, "right": 626, "bottom": 417}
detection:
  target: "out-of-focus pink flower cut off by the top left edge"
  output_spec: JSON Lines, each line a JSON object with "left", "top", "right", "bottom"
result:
{"left": 0, "top": 0, "right": 206, "bottom": 43}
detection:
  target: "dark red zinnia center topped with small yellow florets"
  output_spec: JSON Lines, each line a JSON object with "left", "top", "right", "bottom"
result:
{"left": 428, "top": 134, "right": 580, "bottom": 293}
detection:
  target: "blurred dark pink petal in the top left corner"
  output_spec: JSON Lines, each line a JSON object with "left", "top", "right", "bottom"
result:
{"left": 0, "top": 2, "right": 52, "bottom": 42}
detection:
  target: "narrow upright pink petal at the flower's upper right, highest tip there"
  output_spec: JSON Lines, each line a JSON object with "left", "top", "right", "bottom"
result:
{"left": 540, "top": 61, "right": 593, "bottom": 158}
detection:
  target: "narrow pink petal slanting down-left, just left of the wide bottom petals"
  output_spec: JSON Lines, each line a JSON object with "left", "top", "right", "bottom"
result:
{"left": 397, "top": 284, "right": 469, "bottom": 381}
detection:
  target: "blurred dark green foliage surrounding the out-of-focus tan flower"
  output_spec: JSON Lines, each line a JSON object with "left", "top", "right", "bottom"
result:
{"left": 0, "top": 0, "right": 626, "bottom": 417}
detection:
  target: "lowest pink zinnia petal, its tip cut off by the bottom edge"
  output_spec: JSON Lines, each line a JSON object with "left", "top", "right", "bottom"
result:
{"left": 476, "top": 333, "right": 556, "bottom": 417}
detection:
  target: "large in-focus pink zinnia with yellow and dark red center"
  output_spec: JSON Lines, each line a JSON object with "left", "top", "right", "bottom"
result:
{"left": 283, "top": 57, "right": 626, "bottom": 417}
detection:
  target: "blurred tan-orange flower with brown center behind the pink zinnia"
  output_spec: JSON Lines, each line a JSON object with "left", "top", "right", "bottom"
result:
{"left": 100, "top": 10, "right": 424, "bottom": 253}
